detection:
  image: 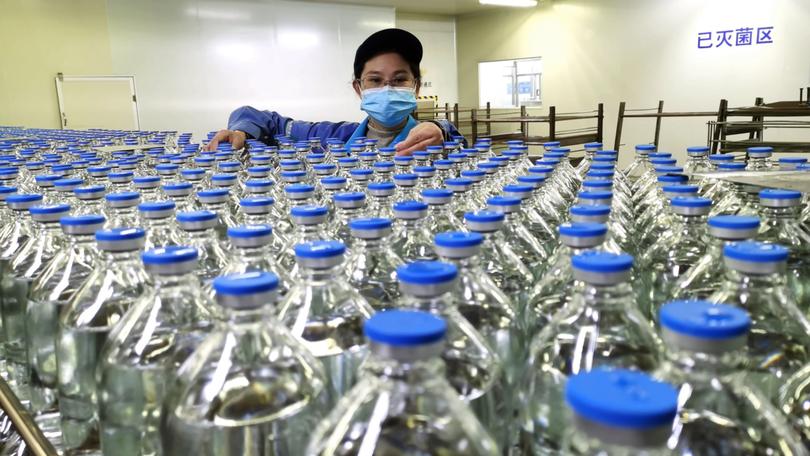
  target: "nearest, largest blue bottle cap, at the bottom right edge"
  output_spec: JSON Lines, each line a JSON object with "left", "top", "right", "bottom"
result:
{"left": 565, "top": 367, "right": 678, "bottom": 429}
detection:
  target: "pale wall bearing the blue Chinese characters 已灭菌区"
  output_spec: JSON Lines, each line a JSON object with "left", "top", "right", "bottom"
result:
{"left": 457, "top": 0, "right": 810, "bottom": 164}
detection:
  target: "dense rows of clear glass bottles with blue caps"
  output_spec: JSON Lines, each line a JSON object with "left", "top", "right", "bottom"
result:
{"left": 0, "top": 126, "right": 810, "bottom": 455}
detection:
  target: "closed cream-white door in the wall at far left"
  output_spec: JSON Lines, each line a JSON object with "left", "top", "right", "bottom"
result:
{"left": 56, "top": 73, "right": 140, "bottom": 130}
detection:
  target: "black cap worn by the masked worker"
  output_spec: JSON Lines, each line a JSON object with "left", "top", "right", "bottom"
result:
{"left": 354, "top": 28, "right": 422, "bottom": 79}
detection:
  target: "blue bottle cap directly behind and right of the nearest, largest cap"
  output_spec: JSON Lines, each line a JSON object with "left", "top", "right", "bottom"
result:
{"left": 658, "top": 301, "right": 751, "bottom": 339}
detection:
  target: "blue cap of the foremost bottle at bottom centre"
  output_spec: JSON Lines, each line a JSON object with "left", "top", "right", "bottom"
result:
{"left": 363, "top": 310, "right": 447, "bottom": 347}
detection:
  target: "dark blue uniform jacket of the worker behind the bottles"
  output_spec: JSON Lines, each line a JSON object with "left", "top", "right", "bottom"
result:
{"left": 228, "top": 106, "right": 466, "bottom": 146}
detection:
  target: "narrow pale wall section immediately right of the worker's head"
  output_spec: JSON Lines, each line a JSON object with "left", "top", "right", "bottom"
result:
{"left": 396, "top": 13, "right": 458, "bottom": 104}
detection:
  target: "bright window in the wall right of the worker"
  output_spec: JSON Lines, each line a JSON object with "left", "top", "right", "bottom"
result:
{"left": 478, "top": 57, "right": 543, "bottom": 108}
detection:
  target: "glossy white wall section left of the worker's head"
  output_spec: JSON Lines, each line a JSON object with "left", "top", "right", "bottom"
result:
{"left": 107, "top": 0, "right": 394, "bottom": 139}
